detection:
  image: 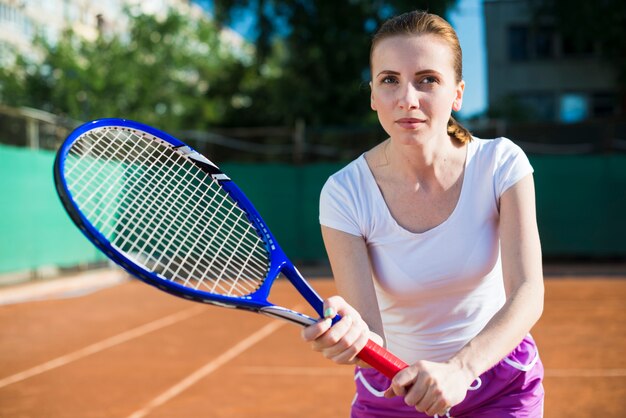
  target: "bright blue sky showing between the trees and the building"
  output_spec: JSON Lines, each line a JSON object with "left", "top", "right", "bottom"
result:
{"left": 195, "top": 0, "right": 487, "bottom": 118}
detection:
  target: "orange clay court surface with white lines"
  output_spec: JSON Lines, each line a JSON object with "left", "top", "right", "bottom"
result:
{"left": 0, "top": 268, "right": 626, "bottom": 418}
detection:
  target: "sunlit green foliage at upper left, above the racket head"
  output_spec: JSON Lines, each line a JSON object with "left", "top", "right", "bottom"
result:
{"left": 0, "top": 8, "right": 245, "bottom": 130}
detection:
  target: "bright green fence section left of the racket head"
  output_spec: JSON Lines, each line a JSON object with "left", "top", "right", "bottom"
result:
{"left": 0, "top": 146, "right": 105, "bottom": 272}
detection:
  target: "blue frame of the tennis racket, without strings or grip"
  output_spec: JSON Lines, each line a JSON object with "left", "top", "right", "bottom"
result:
{"left": 54, "top": 118, "right": 324, "bottom": 326}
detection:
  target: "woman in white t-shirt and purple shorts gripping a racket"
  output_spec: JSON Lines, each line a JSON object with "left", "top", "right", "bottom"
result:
{"left": 303, "top": 11, "right": 544, "bottom": 418}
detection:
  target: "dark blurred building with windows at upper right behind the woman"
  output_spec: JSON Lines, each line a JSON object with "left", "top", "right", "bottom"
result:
{"left": 484, "top": 0, "right": 620, "bottom": 124}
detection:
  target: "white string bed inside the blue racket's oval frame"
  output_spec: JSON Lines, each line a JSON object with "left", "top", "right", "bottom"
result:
{"left": 65, "top": 128, "right": 269, "bottom": 296}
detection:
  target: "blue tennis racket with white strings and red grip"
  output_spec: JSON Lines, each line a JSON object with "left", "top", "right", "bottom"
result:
{"left": 54, "top": 119, "right": 407, "bottom": 378}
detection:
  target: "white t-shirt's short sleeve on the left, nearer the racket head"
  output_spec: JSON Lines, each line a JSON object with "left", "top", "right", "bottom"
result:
{"left": 320, "top": 177, "right": 362, "bottom": 236}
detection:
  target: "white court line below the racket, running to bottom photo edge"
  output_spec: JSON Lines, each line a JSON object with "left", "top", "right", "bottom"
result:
{"left": 128, "top": 320, "right": 286, "bottom": 418}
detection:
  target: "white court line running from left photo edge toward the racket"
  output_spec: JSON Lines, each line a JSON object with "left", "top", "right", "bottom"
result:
{"left": 0, "top": 306, "right": 206, "bottom": 388}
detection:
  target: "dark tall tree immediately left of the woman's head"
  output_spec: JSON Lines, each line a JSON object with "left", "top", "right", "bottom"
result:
{"left": 215, "top": 0, "right": 454, "bottom": 125}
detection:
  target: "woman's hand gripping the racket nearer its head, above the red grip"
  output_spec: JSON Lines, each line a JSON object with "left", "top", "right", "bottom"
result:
{"left": 302, "top": 296, "right": 382, "bottom": 367}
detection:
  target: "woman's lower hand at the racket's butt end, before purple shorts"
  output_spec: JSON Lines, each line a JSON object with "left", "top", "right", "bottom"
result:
{"left": 385, "top": 361, "right": 474, "bottom": 416}
